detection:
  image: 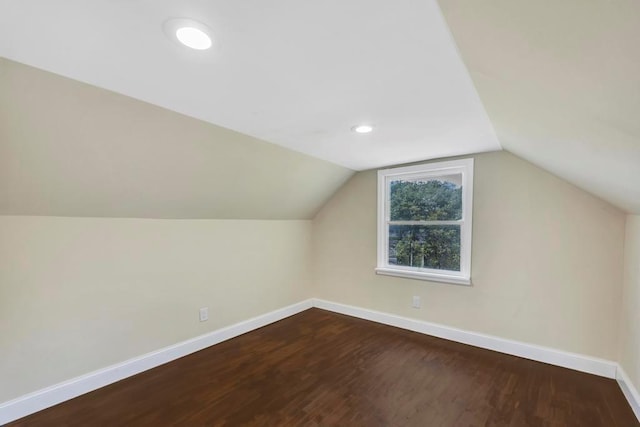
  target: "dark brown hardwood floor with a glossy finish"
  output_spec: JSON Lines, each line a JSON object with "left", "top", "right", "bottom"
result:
{"left": 9, "top": 309, "right": 640, "bottom": 427}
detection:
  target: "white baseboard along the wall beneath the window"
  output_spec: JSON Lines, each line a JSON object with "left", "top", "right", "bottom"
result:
{"left": 313, "top": 298, "right": 617, "bottom": 378}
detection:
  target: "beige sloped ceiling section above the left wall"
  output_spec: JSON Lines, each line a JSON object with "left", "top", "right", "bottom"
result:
{"left": 0, "top": 58, "right": 353, "bottom": 219}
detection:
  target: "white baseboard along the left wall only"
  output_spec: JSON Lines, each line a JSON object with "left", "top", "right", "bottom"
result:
{"left": 0, "top": 299, "right": 313, "bottom": 425}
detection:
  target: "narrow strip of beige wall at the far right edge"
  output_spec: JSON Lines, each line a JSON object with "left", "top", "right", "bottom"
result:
{"left": 620, "top": 215, "right": 640, "bottom": 390}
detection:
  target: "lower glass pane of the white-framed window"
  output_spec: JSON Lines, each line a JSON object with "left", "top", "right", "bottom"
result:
{"left": 389, "top": 225, "right": 460, "bottom": 271}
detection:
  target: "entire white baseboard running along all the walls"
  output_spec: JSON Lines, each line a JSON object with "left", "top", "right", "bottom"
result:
{"left": 0, "top": 298, "right": 640, "bottom": 425}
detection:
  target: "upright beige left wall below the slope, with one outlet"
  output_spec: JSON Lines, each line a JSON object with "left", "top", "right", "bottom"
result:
{"left": 0, "top": 216, "right": 311, "bottom": 402}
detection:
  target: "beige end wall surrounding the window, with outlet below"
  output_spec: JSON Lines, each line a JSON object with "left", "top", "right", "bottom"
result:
{"left": 313, "top": 152, "right": 625, "bottom": 360}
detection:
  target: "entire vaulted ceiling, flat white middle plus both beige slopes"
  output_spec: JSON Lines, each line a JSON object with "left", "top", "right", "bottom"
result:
{"left": 0, "top": 0, "right": 640, "bottom": 218}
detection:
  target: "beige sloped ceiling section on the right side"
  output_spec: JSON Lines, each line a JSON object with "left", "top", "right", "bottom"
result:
{"left": 440, "top": 0, "right": 640, "bottom": 214}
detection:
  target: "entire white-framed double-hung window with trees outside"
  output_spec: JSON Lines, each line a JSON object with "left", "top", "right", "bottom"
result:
{"left": 376, "top": 159, "right": 473, "bottom": 285}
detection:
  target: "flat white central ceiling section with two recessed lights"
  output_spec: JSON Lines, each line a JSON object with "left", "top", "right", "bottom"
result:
{"left": 0, "top": 0, "right": 500, "bottom": 170}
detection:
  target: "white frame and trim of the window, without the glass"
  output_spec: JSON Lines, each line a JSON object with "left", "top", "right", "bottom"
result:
{"left": 376, "top": 159, "right": 473, "bottom": 285}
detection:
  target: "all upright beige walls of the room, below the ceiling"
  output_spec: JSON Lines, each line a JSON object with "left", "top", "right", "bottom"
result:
{"left": 0, "top": 152, "right": 640, "bottom": 402}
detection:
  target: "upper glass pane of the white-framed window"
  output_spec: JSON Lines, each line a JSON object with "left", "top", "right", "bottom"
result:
{"left": 389, "top": 174, "right": 462, "bottom": 221}
